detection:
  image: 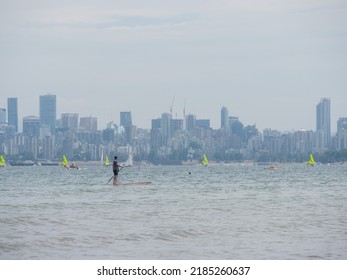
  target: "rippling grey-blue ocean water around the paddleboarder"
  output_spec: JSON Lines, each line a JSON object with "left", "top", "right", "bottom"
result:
{"left": 0, "top": 164, "right": 347, "bottom": 260}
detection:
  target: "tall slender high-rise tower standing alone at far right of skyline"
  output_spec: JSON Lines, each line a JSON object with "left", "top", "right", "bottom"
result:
{"left": 316, "top": 98, "right": 331, "bottom": 148}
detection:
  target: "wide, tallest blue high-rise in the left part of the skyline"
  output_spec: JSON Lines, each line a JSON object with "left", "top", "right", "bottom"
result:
{"left": 40, "top": 94, "right": 57, "bottom": 134}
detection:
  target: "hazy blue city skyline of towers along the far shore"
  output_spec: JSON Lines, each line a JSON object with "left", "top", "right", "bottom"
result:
{"left": 0, "top": 94, "right": 347, "bottom": 164}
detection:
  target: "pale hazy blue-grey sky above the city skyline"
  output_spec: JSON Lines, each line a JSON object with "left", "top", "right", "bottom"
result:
{"left": 0, "top": 0, "right": 347, "bottom": 131}
